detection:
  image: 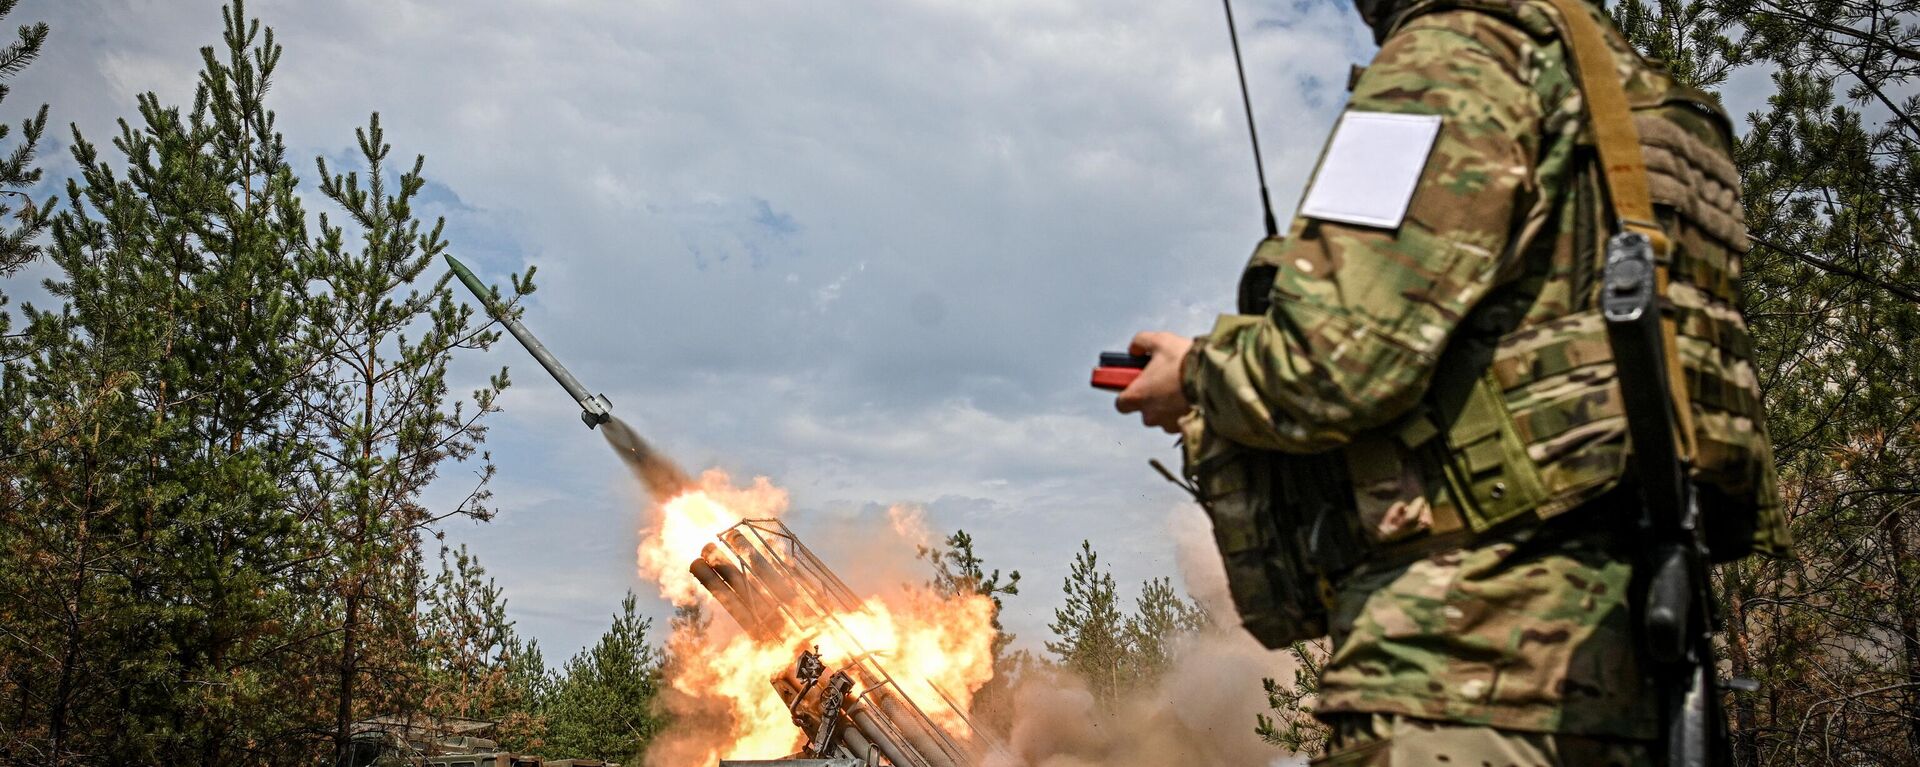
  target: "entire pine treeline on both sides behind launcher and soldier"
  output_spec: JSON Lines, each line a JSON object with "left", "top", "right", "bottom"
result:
{"left": 0, "top": 0, "right": 1920, "bottom": 765}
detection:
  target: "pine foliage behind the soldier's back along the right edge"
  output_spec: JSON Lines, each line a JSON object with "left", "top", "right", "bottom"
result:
{"left": 1622, "top": 0, "right": 1920, "bottom": 765}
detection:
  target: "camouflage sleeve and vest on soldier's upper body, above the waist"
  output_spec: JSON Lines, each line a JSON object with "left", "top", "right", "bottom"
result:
{"left": 1185, "top": 2, "right": 1789, "bottom": 557}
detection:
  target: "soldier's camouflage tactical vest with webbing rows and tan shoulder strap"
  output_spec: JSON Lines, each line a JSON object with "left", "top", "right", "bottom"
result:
{"left": 1346, "top": 0, "right": 1789, "bottom": 561}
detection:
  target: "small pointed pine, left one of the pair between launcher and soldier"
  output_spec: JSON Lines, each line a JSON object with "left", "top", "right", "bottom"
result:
{"left": 1046, "top": 540, "right": 1129, "bottom": 704}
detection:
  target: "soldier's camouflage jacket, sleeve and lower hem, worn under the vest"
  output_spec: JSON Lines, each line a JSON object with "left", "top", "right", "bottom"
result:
{"left": 1183, "top": 2, "right": 1697, "bottom": 738}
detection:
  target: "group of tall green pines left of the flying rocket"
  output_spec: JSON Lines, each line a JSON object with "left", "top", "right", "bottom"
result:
{"left": 0, "top": 0, "right": 653, "bottom": 765}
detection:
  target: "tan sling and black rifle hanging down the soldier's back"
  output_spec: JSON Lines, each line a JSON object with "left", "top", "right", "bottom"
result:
{"left": 1548, "top": 0, "right": 1726, "bottom": 767}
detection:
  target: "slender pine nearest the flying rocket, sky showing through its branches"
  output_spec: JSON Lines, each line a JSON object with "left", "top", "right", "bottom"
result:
{"left": 301, "top": 113, "right": 507, "bottom": 754}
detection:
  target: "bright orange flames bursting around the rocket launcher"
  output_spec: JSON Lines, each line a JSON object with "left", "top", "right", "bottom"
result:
{"left": 637, "top": 469, "right": 995, "bottom": 763}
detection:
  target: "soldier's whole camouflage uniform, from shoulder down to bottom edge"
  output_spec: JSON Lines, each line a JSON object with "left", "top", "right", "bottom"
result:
{"left": 1183, "top": 0, "right": 1788, "bottom": 765}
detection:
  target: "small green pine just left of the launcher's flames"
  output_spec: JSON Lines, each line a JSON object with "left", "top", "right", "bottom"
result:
{"left": 545, "top": 592, "right": 672, "bottom": 765}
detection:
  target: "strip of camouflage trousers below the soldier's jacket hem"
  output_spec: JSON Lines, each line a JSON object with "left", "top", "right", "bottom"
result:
{"left": 1311, "top": 713, "right": 1659, "bottom": 767}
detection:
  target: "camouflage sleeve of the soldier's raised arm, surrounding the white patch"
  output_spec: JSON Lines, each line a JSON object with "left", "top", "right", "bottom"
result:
{"left": 1185, "top": 10, "right": 1542, "bottom": 452}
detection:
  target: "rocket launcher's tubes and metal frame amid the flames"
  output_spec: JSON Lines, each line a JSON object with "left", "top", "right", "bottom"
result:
{"left": 687, "top": 519, "right": 998, "bottom": 767}
